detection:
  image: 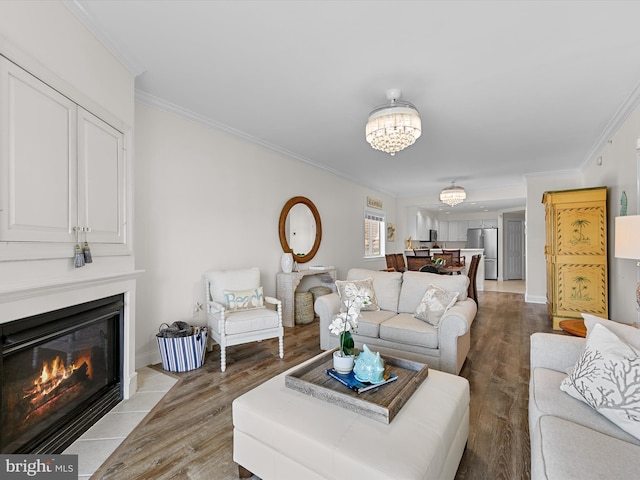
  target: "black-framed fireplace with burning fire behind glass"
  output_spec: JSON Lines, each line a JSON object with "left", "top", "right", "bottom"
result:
{"left": 0, "top": 295, "right": 124, "bottom": 453}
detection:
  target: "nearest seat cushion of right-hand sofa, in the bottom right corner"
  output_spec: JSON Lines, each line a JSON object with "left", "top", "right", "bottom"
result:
{"left": 538, "top": 416, "right": 640, "bottom": 480}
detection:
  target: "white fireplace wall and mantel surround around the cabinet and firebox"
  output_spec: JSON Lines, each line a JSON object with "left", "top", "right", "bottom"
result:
{"left": 0, "top": 1, "right": 136, "bottom": 398}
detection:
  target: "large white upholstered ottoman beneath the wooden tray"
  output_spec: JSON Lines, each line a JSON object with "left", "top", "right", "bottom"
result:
{"left": 233, "top": 352, "right": 469, "bottom": 480}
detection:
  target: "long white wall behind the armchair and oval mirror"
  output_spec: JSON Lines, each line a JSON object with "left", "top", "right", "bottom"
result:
{"left": 135, "top": 102, "right": 401, "bottom": 366}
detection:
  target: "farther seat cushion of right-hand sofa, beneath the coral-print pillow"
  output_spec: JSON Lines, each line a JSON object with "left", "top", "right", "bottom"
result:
{"left": 529, "top": 368, "right": 640, "bottom": 445}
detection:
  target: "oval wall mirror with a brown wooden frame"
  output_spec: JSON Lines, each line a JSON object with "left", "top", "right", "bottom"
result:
{"left": 278, "top": 197, "right": 322, "bottom": 263}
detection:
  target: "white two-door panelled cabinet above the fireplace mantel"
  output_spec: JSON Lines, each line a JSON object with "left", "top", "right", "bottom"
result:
{"left": 0, "top": 57, "right": 126, "bottom": 243}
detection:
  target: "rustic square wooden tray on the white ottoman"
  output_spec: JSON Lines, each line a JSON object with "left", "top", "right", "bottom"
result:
{"left": 285, "top": 349, "right": 429, "bottom": 423}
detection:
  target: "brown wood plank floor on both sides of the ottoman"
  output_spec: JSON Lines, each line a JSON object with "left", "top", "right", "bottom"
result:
{"left": 92, "top": 292, "right": 551, "bottom": 480}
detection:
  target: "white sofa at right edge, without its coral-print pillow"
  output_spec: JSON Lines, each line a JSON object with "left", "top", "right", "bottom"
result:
{"left": 529, "top": 317, "right": 640, "bottom": 480}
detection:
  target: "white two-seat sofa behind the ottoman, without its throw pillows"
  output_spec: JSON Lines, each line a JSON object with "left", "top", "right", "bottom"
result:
{"left": 315, "top": 268, "right": 477, "bottom": 375}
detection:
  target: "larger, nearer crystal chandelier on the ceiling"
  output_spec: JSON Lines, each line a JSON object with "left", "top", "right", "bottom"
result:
{"left": 365, "top": 89, "right": 422, "bottom": 156}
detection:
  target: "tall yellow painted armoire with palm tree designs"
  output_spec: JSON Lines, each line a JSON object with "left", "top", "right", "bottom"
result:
{"left": 542, "top": 187, "right": 608, "bottom": 329}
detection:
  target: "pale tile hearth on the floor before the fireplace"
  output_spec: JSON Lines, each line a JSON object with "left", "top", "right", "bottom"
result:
{"left": 63, "top": 367, "right": 177, "bottom": 480}
